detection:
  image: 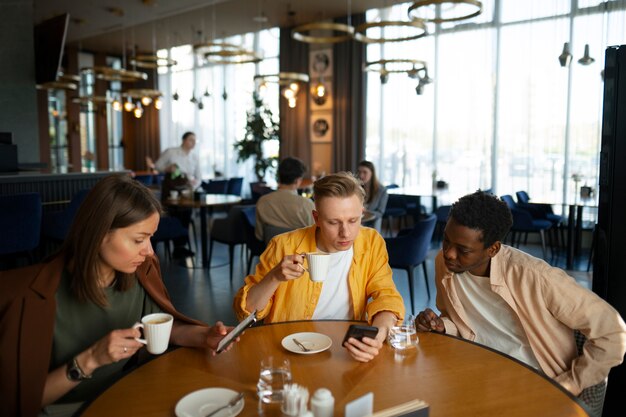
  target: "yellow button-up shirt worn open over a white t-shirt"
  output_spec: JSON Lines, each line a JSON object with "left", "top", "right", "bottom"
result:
{"left": 234, "top": 225, "right": 404, "bottom": 323}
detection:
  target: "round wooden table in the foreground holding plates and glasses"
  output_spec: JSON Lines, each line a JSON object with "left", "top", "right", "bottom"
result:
{"left": 83, "top": 321, "right": 587, "bottom": 417}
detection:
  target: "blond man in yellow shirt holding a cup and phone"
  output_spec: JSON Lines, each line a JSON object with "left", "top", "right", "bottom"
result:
{"left": 234, "top": 172, "right": 404, "bottom": 362}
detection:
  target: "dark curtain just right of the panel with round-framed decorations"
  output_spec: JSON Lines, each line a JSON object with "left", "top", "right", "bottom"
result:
{"left": 332, "top": 13, "right": 367, "bottom": 172}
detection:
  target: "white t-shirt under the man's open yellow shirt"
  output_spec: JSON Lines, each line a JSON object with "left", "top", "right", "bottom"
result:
{"left": 312, "top": 247, "right": 354, "bottom": 320}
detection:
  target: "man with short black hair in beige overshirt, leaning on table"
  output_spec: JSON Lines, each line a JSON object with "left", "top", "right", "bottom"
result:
{"left": 416, "top": 191, "right": 626, "bottom": 414}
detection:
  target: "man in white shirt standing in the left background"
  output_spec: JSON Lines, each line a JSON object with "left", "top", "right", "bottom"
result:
{"left": 154, "top": 132, "right": 202, "bottom": 188}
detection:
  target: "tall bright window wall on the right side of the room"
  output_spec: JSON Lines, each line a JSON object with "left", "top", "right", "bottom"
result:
{"left": 366, "top": 0, "right": 626, "bottom": 210}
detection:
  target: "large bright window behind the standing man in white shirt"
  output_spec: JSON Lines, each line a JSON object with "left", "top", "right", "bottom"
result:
{"left": 159, "top": 28, "right": 279, "bottom": 180}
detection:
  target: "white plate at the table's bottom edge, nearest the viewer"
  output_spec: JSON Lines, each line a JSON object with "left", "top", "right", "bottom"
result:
{"left": 174, "top": 388, "right": 245, "bottom": 417}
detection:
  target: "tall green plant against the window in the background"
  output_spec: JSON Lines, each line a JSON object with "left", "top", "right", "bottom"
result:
{"left": 234, "top": 91, "right": 280, "bottom": 182}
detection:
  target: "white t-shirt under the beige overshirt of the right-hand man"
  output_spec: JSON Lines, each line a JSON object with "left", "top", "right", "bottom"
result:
{"left": 454, "top": 272, "right": 540, "bottom": 369}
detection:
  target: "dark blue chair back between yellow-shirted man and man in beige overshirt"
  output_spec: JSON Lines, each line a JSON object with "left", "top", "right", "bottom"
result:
{"left": 385, "top": 214, "right": 437, "bottom": 265}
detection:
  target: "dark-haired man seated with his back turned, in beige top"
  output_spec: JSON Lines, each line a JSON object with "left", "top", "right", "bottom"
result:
{"left": 254, "top": 157, "right": 315, "bottom": 240}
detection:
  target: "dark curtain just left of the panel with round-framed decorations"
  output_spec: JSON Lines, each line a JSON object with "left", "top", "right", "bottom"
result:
{"left": 279, "top": 28, "right": 311, "bottom": 167}
